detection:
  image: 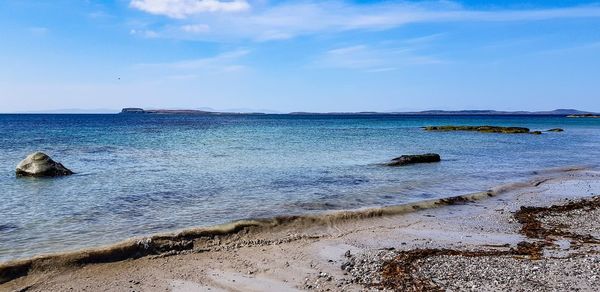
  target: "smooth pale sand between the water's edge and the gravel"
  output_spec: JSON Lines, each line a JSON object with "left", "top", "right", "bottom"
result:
{"left": 0, "top": 170, "right": 600, "bottom": 291}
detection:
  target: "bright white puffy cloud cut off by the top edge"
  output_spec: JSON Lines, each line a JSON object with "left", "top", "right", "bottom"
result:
{"left": 130, "top": 0, "right": 250, "bottom": 18}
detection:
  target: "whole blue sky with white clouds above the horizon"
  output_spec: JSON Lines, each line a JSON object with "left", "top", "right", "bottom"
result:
{"left": 0, "top": 0, "right": 600, "bottom": 112}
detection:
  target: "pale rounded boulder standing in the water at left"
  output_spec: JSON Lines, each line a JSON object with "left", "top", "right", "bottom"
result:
{"left": 16, "top": 152, "right": 73, "bottom": 177}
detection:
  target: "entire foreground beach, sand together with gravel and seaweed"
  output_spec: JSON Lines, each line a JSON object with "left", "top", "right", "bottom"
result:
{"left": 0, "top": 170, "right": 600, "bottom": 291}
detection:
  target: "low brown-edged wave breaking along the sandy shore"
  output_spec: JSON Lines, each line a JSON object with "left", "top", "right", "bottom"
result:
{"left": 0, "top": 168, "right": 589, "bottom": 284}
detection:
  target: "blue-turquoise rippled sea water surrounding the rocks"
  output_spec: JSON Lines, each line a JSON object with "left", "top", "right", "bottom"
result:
{"left": 0, "top": 115, "right": 600, "bottom": 261}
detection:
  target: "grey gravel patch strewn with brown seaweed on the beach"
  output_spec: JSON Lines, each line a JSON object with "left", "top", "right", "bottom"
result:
{"left": 341, "top": 197, "right": 600, "bottom": 291}
